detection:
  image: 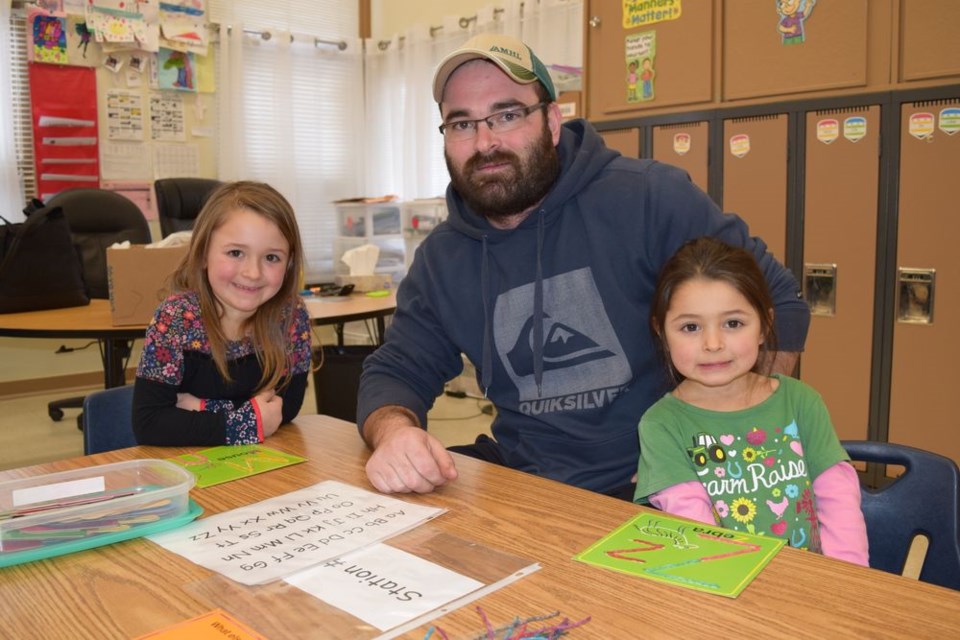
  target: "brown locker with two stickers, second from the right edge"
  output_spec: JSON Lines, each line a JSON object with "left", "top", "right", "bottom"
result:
{"left": 800, "top": 106, "right": 880, "bottom": 440}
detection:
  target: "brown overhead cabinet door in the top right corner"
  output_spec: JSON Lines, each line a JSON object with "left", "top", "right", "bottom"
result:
{"left": 897, "top": 0, "right": 960, "bottom": 82}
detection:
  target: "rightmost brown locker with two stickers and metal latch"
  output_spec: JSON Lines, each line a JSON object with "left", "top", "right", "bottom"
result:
{"left": 888, "top": 99, "right": 960, "bottom": 462}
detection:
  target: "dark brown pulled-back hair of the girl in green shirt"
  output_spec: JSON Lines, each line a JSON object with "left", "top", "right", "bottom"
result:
{"left": 650, "top": 237, "right": 777, "bottom": 383}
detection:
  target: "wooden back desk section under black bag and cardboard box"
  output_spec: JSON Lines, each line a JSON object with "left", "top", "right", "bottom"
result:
{"left": 0, "top": 299, "right": 146, "bottom": 389}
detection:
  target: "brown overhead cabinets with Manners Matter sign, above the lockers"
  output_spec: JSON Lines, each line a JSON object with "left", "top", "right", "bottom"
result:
{"left": 583, "top": 0, "right": 960, "bottom": 122}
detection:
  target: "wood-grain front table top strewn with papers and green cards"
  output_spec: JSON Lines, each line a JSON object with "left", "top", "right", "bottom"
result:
{"left": 0, "top": 416, "right": 960, "bottom": 640}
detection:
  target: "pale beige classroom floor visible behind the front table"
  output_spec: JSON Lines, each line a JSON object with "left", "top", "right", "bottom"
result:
{"left": 0, "top": 381, "right": 491, "bottom": 469}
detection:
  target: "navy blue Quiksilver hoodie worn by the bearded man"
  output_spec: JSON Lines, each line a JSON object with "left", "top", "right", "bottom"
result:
{"left": 357, "top": 120, "right": 810, "bottom": 492}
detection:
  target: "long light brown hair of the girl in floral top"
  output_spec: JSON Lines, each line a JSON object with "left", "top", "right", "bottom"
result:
{"left": 172, "top": 181, "right": 303, "bottom": 393}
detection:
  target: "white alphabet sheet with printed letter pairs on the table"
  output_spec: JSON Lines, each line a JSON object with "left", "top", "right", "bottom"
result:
{"left": 149, "top": 480, "right": 445, "bottom": 585}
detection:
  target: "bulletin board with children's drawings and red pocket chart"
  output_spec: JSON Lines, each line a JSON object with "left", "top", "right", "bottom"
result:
{"left": 27, "top": 0, "right": 216, "bottom": 209}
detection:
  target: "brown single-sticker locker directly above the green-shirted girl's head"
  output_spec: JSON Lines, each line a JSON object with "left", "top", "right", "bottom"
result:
{"left": 723, "top": 113, "right": 788, "bottom": 262}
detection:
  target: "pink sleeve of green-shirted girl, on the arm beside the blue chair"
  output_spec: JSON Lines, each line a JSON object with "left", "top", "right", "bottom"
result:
{"left": 813, "top": 462, "right": 870, "bottom": 567}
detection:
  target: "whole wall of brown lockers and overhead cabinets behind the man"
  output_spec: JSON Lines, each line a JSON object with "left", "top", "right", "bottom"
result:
{"left": 584, "top": 0, "right": 960, "bottom": 462}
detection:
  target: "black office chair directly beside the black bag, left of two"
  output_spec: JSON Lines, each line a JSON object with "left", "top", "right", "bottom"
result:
{"left": 46, "top": 189, "right": 151, "bottom": 428}
